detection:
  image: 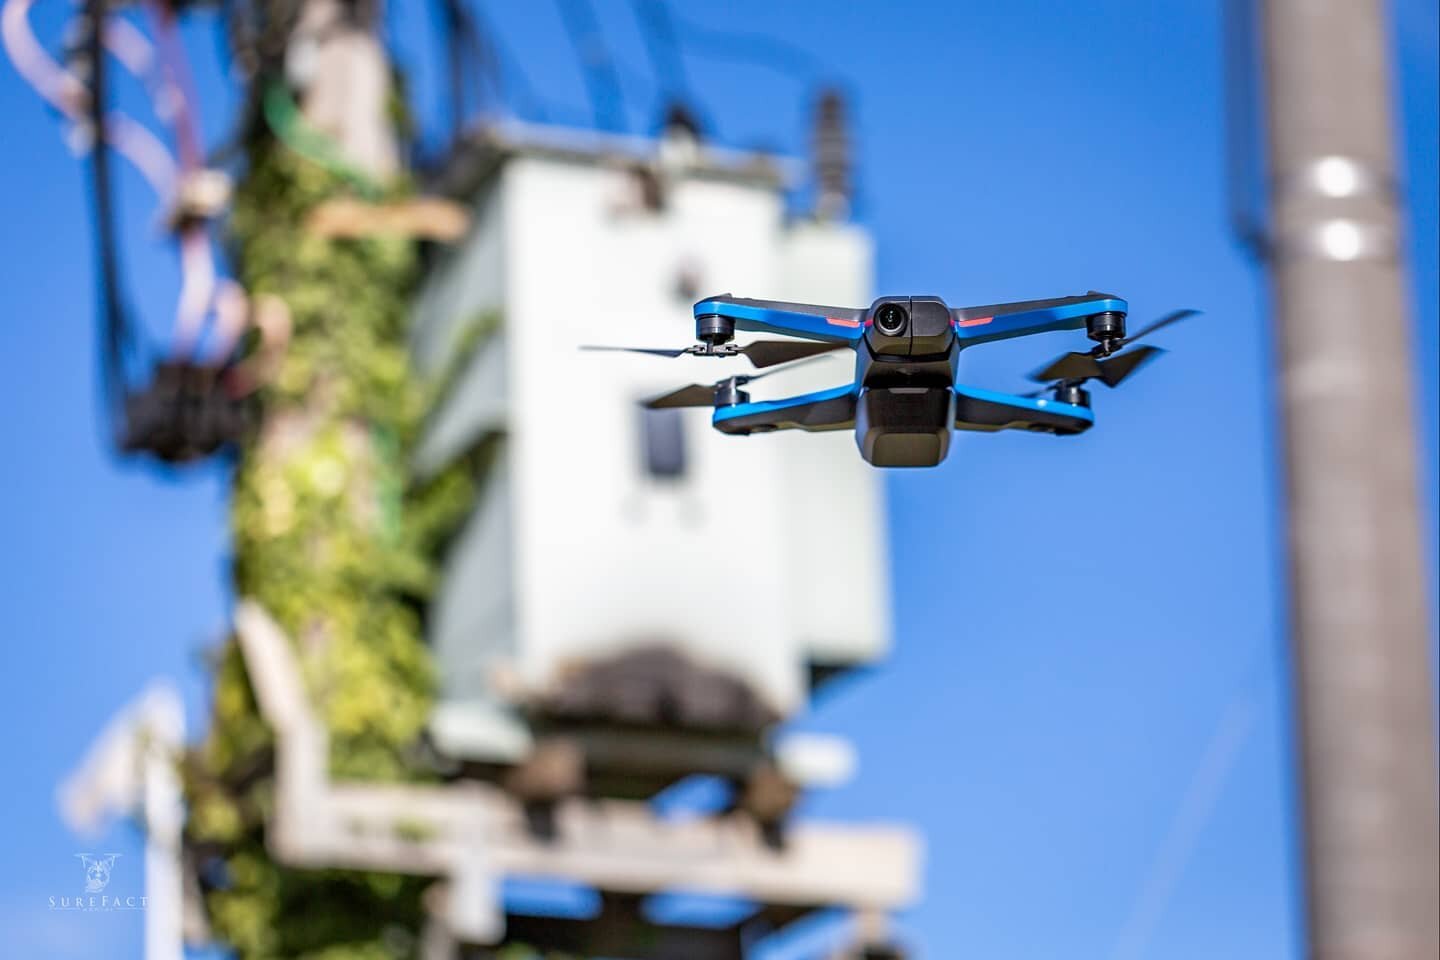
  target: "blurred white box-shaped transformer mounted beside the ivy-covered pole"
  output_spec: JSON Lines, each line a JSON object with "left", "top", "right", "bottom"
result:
{"left": 400, "top": 124, "right": 890, "bottom": 782}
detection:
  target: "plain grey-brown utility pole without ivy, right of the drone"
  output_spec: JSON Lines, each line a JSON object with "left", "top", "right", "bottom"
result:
{"left": 1263, "top": 0, "right": 1440, "bottom": 960}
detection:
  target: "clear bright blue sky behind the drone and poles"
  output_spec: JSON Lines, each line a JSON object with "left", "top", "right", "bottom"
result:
{"left": 0, "top": 0, "right": 1440, "bottom": 959}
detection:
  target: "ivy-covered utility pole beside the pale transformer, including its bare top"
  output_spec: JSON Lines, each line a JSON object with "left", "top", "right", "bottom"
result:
{"left": 186, "top": 0, "right": 443, "bottom": 959}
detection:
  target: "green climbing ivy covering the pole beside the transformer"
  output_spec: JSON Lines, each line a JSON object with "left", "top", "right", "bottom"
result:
{"left": 186, "top": 135, "right": 474, "bottom": 960}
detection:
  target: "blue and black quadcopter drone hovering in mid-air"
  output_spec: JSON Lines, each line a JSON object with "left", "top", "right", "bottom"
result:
{"left": 586, "top": 291, "right": 1198, "bottom": 466}
